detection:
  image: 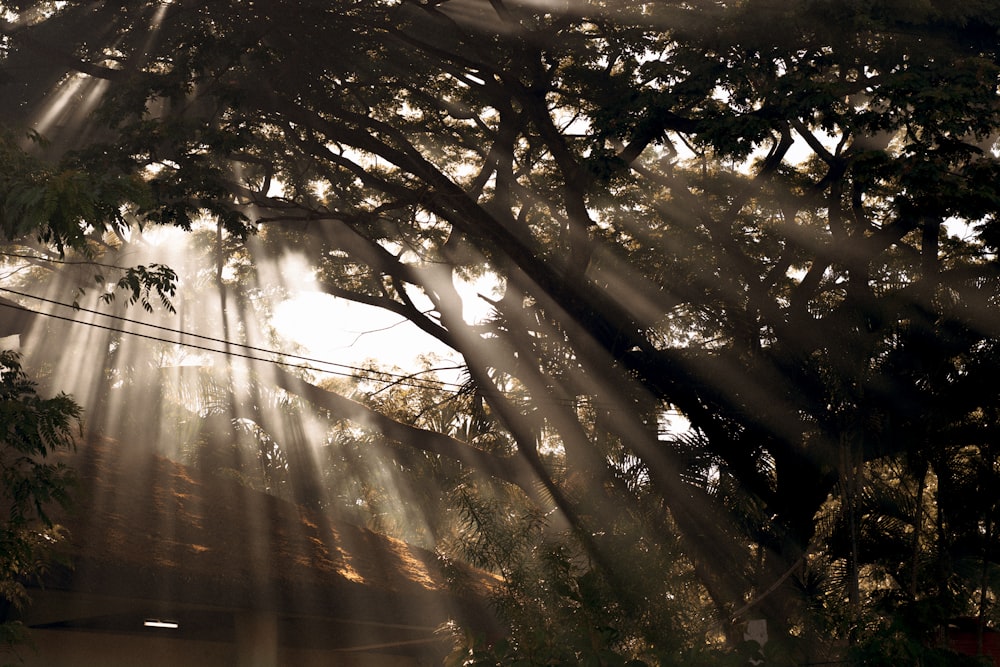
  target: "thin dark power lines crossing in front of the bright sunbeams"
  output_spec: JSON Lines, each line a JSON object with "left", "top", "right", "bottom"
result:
{"left": 0, "top": 287, "right": 462, "bottom": 390}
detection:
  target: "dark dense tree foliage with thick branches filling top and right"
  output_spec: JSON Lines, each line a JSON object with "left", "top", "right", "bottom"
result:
{"left": 0, "top": 0, "right": 1000, "bottom": 664}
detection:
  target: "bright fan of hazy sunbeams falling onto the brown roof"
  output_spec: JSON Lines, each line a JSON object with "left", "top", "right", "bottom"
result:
{"left": 1, "top": 217, "right": 498, "bottom": 664}
